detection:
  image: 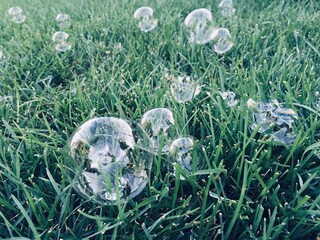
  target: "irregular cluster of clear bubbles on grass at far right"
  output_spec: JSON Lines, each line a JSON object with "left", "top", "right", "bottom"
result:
{"left": 247, "top": 99, "right": 298, "bottom": 145}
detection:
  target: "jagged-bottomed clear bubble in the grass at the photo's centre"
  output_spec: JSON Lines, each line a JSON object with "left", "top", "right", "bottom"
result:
{"left": 170, "top": 76, "right": 201, "bottom": 103}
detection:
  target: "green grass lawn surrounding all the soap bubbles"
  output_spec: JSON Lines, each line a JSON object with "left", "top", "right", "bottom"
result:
{"left": 0, "top": 0, "right": 320, "bottom": 239}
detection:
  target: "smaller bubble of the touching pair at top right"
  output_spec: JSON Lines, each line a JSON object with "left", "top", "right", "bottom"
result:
{"left": 212, "top": 28, "right": 233, "bottom": 54}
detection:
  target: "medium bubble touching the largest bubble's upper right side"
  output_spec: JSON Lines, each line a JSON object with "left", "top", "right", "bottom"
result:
{"left": 141, "top": 108, "right": 174, "bottom": 153}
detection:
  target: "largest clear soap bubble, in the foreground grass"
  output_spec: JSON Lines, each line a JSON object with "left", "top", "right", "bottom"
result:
{"left": 69, "top": 117, "right": 150, "bottom": 205}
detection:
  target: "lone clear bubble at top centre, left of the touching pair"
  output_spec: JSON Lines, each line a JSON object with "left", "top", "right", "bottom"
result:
{"left": 133, "top": 7, "right": 158, "bottom": 32}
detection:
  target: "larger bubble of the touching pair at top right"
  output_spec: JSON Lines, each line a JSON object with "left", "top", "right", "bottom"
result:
{"left": 184, "top": 8, "right": 214, "bottom": 44}
